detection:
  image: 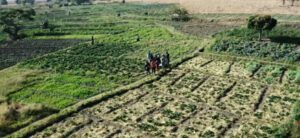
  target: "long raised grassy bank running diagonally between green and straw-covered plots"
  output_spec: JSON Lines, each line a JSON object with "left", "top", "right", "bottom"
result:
{"left": 5, "top": 47, "right": 203, "bottom": 138}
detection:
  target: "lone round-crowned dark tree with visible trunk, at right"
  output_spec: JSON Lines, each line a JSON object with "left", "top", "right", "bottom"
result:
{"left": 248, "top": 15, "right": 277, "bottom": 40}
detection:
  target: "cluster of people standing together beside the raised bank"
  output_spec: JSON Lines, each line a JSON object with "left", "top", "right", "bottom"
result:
{"left": 145, "top": 51, "right": 170, "bottom": 74}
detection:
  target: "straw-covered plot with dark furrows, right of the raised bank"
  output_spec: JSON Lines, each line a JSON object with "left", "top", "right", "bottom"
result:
{"left": 31, "top": 55, "right": 300, "bottom": 138}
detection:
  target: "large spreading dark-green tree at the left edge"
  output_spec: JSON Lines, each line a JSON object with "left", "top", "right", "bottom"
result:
{"left": 0, "top": 9, "right": 35, "bottom": 40}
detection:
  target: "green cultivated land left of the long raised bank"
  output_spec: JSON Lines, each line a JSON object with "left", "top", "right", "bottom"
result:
{"left": 0, "top": 3, "right": 203, "bottom": 135}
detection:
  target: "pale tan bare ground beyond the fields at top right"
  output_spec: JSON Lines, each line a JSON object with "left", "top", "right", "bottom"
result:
{"left": 127, "top": 0, "right": 300, "bottom": 15}
